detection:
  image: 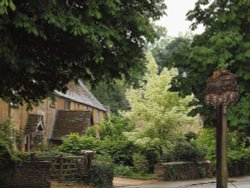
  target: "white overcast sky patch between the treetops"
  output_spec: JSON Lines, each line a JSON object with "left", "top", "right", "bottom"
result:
{"left": 156, "top": 0, "right": 204, "bottom": 37}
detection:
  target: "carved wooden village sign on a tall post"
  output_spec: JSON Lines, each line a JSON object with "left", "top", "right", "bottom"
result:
{"left": 205, "top": 70, "right": 239, "bottom": 188}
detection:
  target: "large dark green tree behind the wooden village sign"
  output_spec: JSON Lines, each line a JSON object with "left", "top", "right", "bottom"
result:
{"left": 168, "top": 0, "right": 250, "bottom": 145}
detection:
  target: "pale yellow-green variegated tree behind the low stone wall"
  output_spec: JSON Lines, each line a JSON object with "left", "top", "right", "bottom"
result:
{"left": 124, "top": 54, "right": 198, "bottom": 156}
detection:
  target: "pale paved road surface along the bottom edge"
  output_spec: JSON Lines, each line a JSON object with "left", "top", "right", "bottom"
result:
{"left": 113, "top": 176, "right": 250, "bottom": 188}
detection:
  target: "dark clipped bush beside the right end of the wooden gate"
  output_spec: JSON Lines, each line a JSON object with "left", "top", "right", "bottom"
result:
{"left": 83, "top": 162, "right": 113, "bottom": 188}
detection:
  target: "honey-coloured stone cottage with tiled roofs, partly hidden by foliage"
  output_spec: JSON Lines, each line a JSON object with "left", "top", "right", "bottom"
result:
{"left": 0, "top": 81, "right": 106, "bottom": 151}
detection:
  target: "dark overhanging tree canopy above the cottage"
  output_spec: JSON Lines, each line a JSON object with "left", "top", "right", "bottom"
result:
{"left": 0, "top": 0, "right": 165, "bottom": 106}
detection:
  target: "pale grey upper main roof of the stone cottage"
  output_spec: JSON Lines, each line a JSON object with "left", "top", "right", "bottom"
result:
{"left": 55, "top": 80, "right": 107, "bottom": 111}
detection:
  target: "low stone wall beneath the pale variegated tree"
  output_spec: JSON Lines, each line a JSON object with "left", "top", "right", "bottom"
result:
{"left": 154, "top": 161, "right": 212, "bottom": 181}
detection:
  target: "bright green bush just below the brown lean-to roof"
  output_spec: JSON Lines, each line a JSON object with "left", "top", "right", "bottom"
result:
{"left": 59, "top": 133, "right": 99, "bottom": 155}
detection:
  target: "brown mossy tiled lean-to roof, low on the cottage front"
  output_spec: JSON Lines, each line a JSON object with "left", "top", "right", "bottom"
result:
{"left": 51, "top": 110, "right": 91, "bottom": 140}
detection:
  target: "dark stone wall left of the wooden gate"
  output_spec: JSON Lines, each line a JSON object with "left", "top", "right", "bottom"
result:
{"left": 3, "top": 161, "right": 51, "bottom": 188}
